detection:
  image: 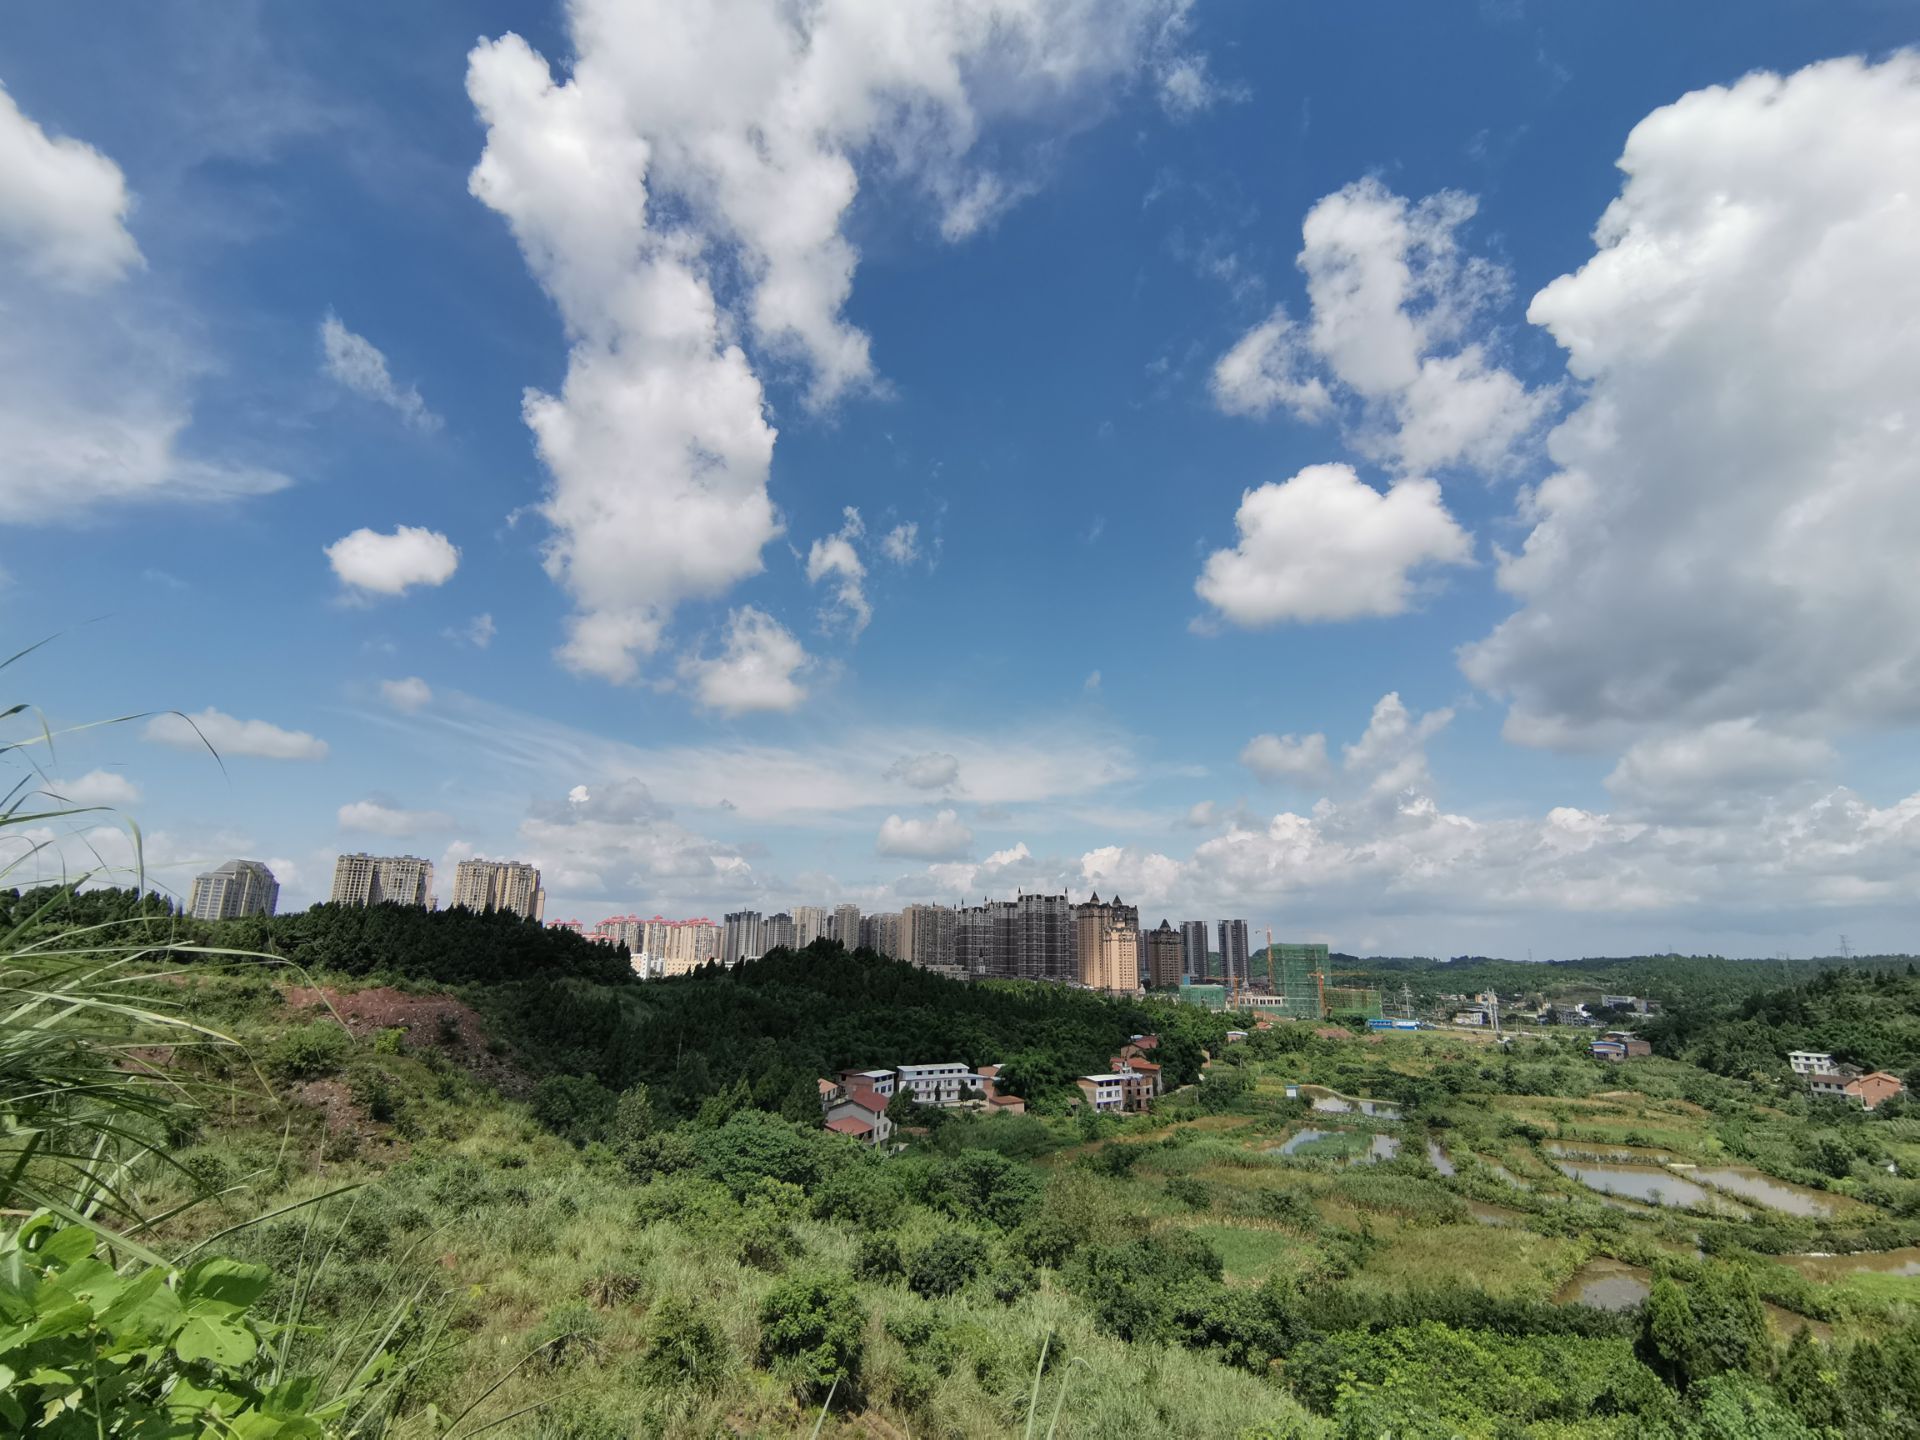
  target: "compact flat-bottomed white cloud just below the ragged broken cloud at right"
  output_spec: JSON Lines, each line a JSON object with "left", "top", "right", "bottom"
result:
{"left": 1194, "top": 465, "right": 1473, "bottom": 626}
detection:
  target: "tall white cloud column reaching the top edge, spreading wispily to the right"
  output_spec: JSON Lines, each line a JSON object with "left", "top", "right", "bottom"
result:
{"left": 467, "top": 0, "right": 1187, "bottom": 680}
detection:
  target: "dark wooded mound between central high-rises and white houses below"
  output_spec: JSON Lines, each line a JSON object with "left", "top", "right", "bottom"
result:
{"left": 490, "top": 941, "right": 1231, "bottom": 1116}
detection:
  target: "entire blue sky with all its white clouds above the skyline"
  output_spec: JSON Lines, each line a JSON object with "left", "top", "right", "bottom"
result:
{"left": 0, "top": 0, "right": 1920, "bottom": 956}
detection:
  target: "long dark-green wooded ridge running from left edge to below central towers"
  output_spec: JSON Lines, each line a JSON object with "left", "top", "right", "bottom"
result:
{"left": 0, "top": 887, "right": 1233, "bottom": 1119}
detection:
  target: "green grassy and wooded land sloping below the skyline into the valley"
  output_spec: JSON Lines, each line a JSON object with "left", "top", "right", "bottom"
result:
{"left": 11, "top": 914, "right": 1920, "bottom": 1438}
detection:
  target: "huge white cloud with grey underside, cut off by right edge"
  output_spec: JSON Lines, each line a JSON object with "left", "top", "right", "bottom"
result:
{"left": 1463, "top": 52, "right": 1920, "bottom": 756}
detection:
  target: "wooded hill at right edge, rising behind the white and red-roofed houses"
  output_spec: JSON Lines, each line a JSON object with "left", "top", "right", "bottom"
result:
{"left": 1645, "top": 964, "right": 1920, "bottom": 1085}
